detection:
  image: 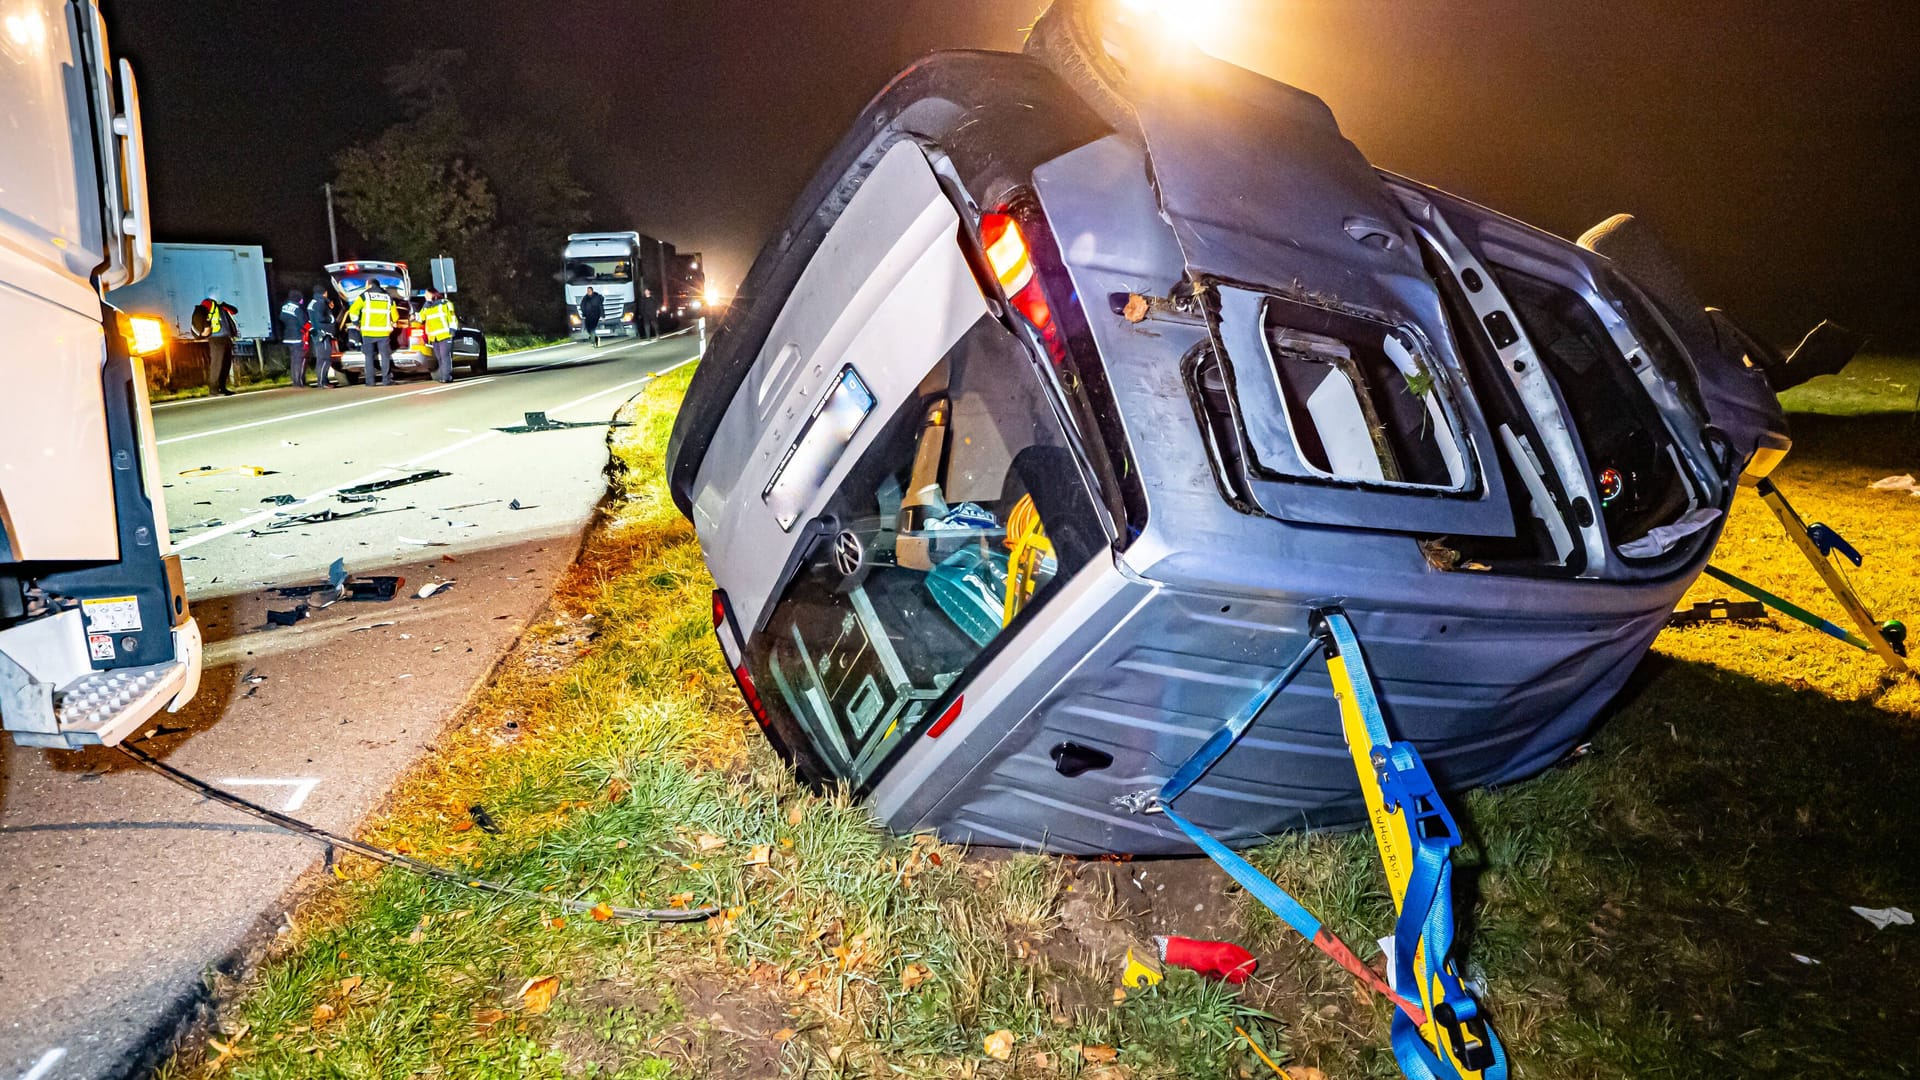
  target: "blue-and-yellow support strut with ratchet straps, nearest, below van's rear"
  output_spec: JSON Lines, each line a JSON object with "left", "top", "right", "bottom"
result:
{"left": 1133, "top": 611, "right": 1507, "bottom": 1080}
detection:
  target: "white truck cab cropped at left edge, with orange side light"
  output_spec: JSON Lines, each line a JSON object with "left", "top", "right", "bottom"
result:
{"left": 0, "top": 0, "right": 202, "bottom": 748}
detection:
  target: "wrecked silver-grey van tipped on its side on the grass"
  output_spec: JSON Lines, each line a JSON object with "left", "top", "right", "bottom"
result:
{"left": 668, "top": 10, "right": 1811, "bottom": 853}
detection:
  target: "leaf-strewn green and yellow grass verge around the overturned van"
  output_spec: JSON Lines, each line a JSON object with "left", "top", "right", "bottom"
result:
{"left": 161, "top": 361, "right": 1920, "bottom": 1080}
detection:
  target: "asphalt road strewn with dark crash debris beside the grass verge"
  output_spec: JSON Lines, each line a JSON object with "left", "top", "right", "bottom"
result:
{"left": 0, "top": 334, "right": 699, "bottom": 1080}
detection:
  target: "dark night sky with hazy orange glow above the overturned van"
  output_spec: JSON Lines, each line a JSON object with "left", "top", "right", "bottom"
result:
{"left": 106, "top": 0, "right": 1920, "bottom": 344}
